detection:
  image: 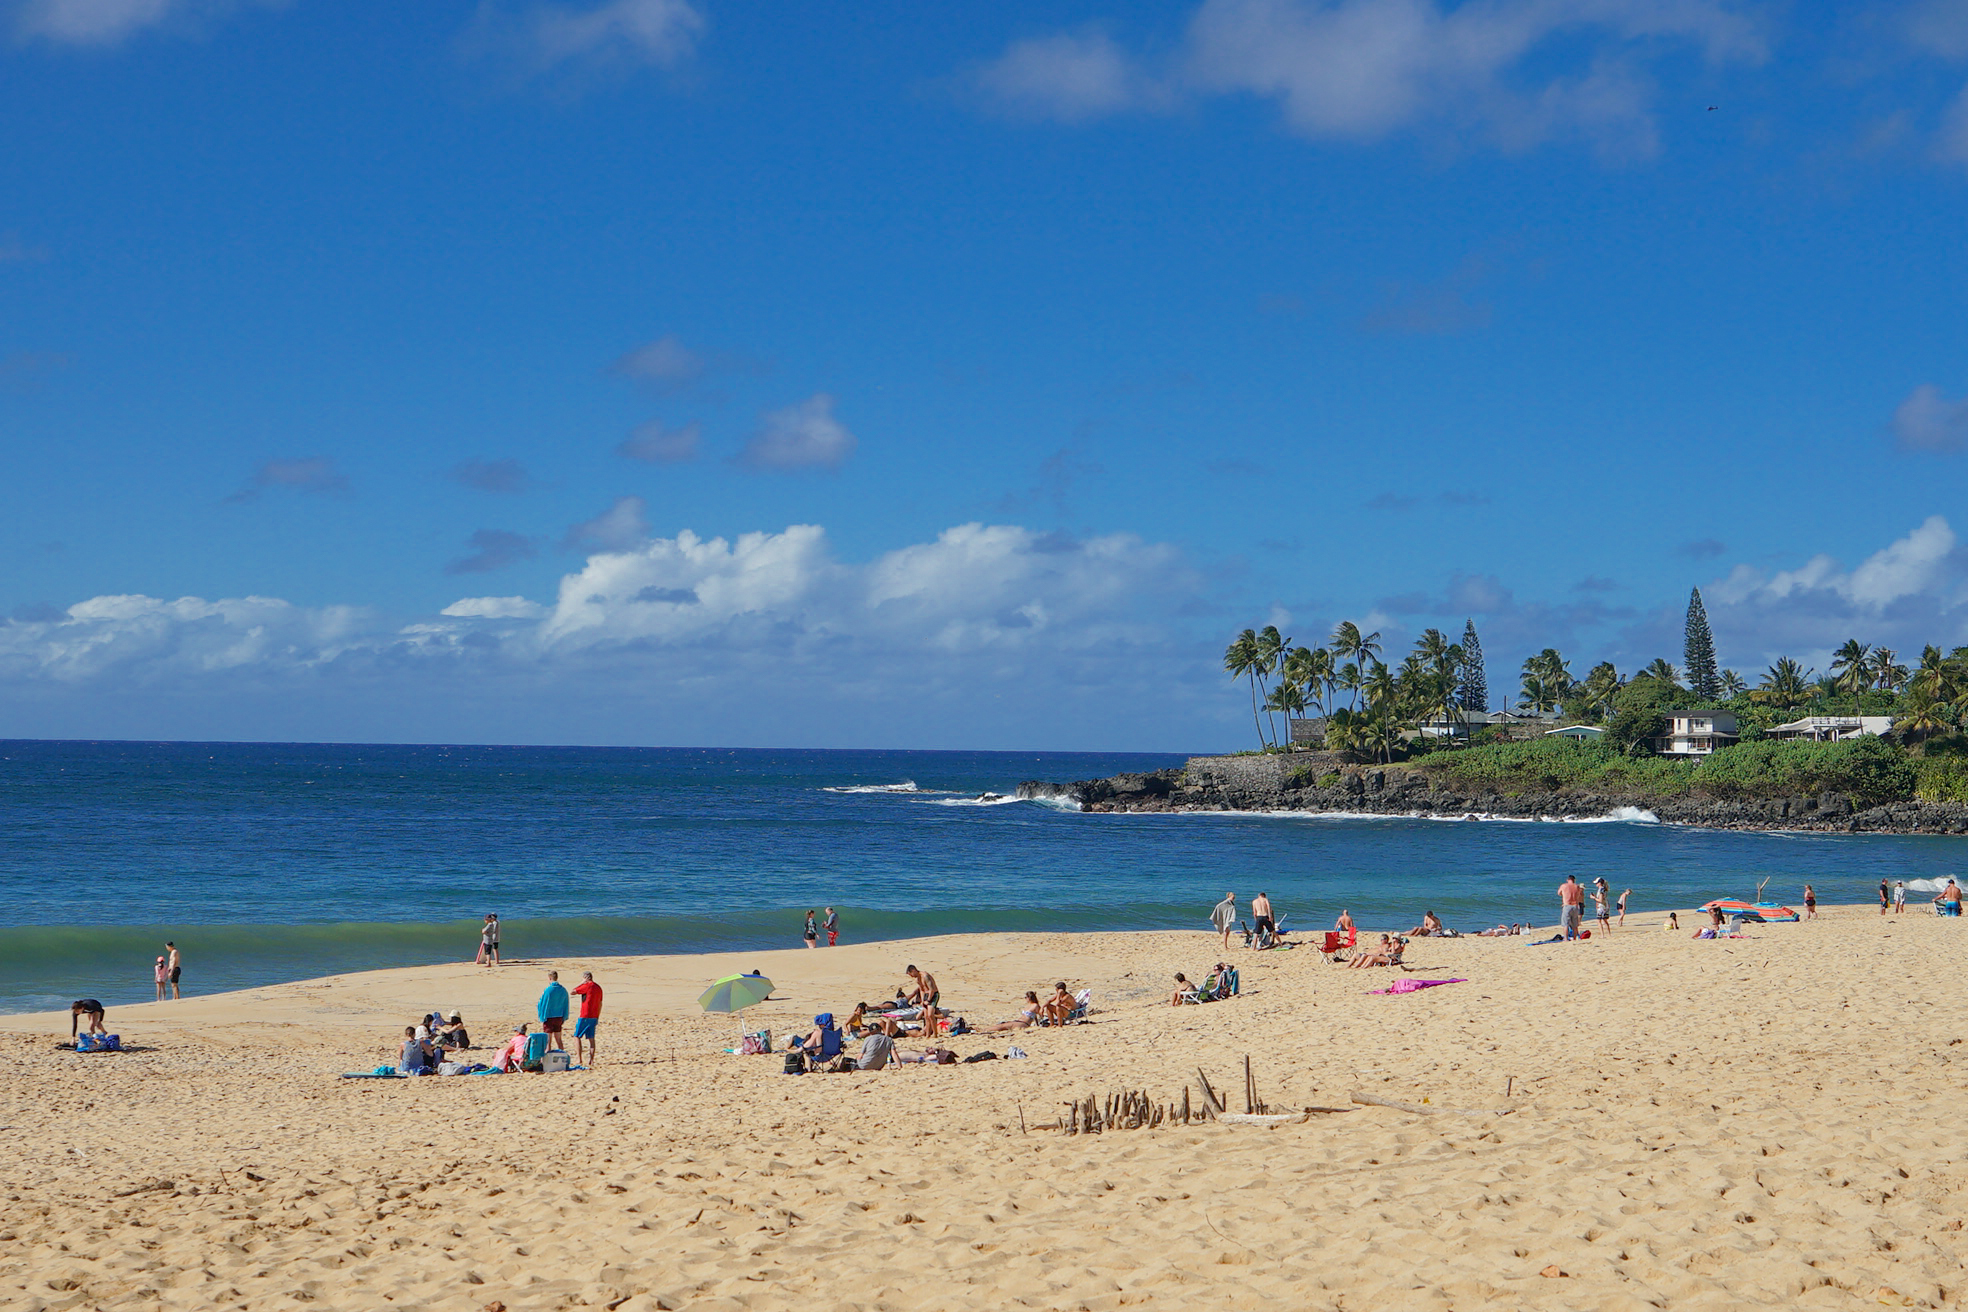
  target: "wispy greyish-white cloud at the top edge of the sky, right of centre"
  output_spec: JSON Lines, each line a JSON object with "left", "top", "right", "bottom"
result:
{"left": 972, "top": 0, "right": 1763, "bottom": 153}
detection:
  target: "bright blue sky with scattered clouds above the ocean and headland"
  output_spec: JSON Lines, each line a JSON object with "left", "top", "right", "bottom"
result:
{"left": 0, "top": 0, "right": 1968, "bottom": 749}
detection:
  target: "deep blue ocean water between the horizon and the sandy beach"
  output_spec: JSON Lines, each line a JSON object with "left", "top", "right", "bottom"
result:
{"left": 0, "top": 742, "right": 1968, "bottom": 1011}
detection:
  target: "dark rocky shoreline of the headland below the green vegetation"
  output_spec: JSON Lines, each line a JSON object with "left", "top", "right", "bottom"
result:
{"left": 1017, "top": 751, "right": 1968, "bottom": 834}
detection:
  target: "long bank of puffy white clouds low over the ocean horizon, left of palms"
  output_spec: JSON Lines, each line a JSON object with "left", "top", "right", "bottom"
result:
{"left": 0, "top": 523, "right": 1196, "bottom": 745}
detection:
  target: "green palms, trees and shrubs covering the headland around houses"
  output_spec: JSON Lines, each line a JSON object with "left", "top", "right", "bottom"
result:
{"left": 1224, "top": 609, "right": 1968, "bottom": 806}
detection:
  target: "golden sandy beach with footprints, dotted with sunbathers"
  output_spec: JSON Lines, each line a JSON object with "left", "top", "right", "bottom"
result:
{"left": 0, "top": 903, "right": 1968, "bottom": 1312}
